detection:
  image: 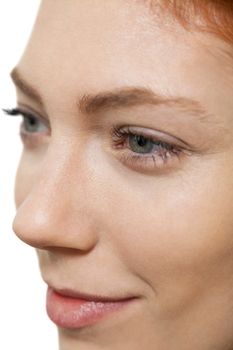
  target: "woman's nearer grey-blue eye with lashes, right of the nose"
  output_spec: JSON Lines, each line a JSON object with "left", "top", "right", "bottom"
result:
{"left": 112, "top": 126, "right": 191, "bottom": 171}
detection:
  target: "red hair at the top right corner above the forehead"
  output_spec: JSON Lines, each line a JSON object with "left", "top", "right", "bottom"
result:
{"left": 150, "top": 0, "right": 233, "bottom": 44}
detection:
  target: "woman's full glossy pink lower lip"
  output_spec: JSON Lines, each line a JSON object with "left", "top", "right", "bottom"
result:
{"left": 46, "top": 288, "right": 132, "bottom": 329}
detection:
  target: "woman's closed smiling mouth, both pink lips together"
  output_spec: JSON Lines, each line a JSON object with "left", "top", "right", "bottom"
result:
{"left": 46, "top": 287, "right": 137, "bottom": 329}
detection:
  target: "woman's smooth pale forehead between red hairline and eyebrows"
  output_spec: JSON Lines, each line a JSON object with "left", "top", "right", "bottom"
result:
{"left": 19, "top": 0, "right": 233, "bottom": 126}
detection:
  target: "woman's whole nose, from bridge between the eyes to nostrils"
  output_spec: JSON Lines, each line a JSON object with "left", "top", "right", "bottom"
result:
{"left": 13, "top": 141, "right": 99, "bottom": 252}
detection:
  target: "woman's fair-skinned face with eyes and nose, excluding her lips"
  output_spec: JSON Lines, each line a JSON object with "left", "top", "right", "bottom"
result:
{"left": 13, "top": 0, "right": 233, "bottom": 350}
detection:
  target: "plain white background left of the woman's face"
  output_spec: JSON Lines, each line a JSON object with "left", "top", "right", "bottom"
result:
{"left": 0, "top": 0, "right": 58, "bottom": 350}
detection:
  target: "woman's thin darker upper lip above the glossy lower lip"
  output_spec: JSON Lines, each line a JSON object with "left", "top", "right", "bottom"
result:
{"left": 50, "top": 287, "right": 136, "bottom": 302}
